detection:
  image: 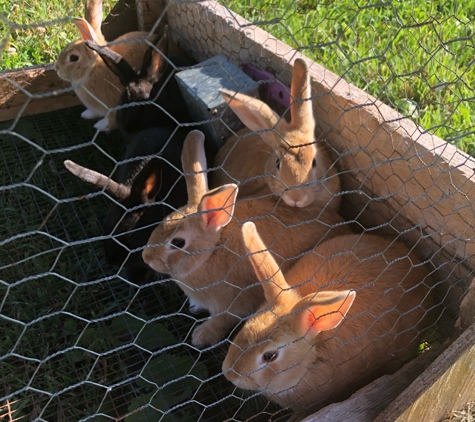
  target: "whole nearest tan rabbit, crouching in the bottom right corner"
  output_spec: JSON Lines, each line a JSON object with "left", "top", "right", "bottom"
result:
{"left": 223, "top": 223, "right": 434, "bottom": 420}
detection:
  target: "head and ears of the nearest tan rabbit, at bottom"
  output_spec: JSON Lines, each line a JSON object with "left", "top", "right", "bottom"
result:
{"left": 223, "top": 222, "right": 356, "bottom": 407}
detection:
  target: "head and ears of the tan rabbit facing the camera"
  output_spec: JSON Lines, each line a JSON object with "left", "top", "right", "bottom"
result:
{"left": 220, "top": 58, "right": 340, "bottom": 207}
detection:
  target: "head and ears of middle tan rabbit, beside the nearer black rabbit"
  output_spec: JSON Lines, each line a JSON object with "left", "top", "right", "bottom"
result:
{"left": 143, "top": 130, "right": 237, "bottom": 277}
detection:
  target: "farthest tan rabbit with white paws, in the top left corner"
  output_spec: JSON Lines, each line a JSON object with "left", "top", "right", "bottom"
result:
{"left": 54, "top": 0, "right": 153, "bottom": 131}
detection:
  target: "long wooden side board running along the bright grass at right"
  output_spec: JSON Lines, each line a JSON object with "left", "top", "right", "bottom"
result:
{"left": 168, "top": 1, "right": 475, "bottom": 294}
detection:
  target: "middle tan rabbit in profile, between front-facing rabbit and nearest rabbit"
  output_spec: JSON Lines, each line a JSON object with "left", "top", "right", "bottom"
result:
{"left": 142, "top": 131, "right": 349, "bottom": 346}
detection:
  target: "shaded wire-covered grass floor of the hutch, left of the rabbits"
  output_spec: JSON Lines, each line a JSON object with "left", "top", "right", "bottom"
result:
{"left": 0, "top": 106, "right": 294, "bottom": 422}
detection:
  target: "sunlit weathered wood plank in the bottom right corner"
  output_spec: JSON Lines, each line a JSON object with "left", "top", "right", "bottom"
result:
{"left": 375, "top": 324, "right": 475, "bottom": 422}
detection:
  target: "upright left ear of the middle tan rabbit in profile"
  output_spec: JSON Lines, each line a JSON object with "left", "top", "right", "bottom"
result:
{"left": 181, "top": 130, "right": 208, "bottom": 205}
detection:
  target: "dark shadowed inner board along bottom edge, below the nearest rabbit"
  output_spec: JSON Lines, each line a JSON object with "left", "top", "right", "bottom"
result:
{"left": 302, "top": 350, "right": 440, "bottom": 422}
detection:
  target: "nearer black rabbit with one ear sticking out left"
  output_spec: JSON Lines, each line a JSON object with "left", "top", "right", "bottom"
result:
{"left": 64, "top": 127, "right": 189, "bottom": 283}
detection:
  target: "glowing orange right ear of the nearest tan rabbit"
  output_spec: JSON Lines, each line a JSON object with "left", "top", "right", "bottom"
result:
{"left": 293, "top": 290, "right": 356, "bottom": 337}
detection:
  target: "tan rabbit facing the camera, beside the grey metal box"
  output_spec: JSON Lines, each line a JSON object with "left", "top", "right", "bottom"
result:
{"left": 214, "top": 58, "right": 341, "bottom": 211}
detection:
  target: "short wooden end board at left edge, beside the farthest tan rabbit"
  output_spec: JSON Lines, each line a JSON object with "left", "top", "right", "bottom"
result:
{"left": 0, "top": 65, "right": 80, "bottom": 121}
